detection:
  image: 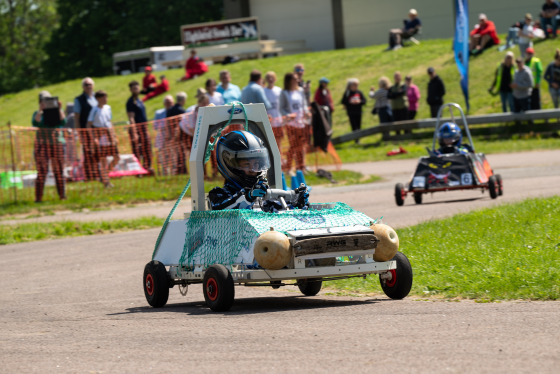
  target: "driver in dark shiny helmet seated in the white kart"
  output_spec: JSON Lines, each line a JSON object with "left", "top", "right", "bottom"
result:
{"left": 208, "top": 131, "right": 309, "bottom": 211}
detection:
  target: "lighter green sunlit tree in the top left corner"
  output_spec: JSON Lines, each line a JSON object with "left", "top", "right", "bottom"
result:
{"left": 0, "top": 0, "right": 57, "bottom": 95}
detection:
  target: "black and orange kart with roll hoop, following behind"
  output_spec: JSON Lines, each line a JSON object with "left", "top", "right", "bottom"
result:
{"left": 395, "top": 103, "right": 503, "bottom": 206}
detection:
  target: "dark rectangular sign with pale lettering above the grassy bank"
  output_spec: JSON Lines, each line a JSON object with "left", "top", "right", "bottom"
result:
{"left": 181, "top": 18, "right": 259, "bottom": 48}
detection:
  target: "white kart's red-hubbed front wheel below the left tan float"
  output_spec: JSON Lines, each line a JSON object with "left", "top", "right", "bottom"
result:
{"left": 202, "top": 265, "right": 235, "bottom": 312}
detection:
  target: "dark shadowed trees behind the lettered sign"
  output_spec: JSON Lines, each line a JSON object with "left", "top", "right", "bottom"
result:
{"left": 45, "top": 0, "right": 223, "bottom": 81}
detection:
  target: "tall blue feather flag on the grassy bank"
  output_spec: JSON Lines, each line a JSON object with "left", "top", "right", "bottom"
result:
{"left": 453, "top": 0, "right": 470, "bottom": 112}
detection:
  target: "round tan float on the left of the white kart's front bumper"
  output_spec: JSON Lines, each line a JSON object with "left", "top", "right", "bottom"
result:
{"left": 253, "top": 229, "right": 292, "bottom": 270}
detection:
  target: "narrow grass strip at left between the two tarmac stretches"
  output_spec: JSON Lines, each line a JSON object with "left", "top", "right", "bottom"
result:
{"left": 0, "top": 217, "right": 163, "bottom": 245}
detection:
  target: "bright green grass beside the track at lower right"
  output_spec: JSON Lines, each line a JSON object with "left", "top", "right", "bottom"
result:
{"left": 329, "top": 196, "right": 560, "bottom": 301}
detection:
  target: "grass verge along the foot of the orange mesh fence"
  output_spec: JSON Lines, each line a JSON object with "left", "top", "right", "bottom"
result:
{"left": 0, "top": 170, "right": 380, "bottom": 218}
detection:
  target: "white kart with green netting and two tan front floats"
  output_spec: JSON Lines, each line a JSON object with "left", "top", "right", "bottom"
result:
{"left": 143, "top": 104, "right": 412, "bottom": 311}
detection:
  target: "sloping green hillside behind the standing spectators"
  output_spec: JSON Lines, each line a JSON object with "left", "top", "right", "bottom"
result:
{"left": 0, "top": 40, "right": 558, "bottom": 134}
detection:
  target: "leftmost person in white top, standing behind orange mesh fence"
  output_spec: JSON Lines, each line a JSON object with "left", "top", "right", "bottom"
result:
{"left": 88, "top": 90, "right": 120, "bottom": 188}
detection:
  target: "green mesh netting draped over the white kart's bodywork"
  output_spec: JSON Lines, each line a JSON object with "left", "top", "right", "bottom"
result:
{"left": 179, "top": 203, "right": 375, "bottom": 268}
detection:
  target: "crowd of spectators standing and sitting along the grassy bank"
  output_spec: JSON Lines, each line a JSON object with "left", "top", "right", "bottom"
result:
{"left": 32, "top": 0, "right": 560, "bottom": 202}
